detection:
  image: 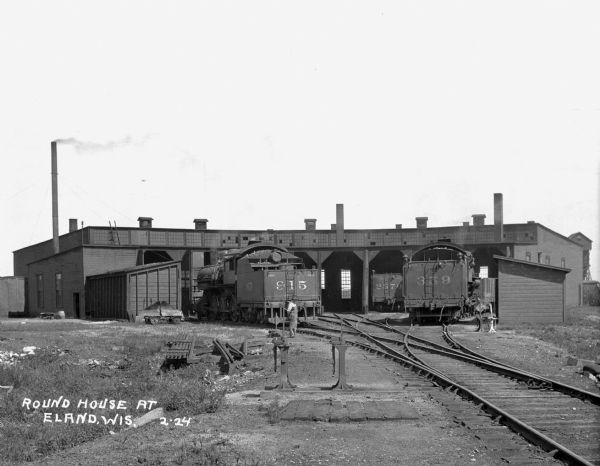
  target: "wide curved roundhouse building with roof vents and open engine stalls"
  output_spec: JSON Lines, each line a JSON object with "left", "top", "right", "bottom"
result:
{"left": 14, "top": 193, "right": 591, "bottom": 318}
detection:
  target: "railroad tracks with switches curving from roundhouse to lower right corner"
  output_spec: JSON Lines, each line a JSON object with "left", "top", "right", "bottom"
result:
{"left": 305, "top": 315, "right": 600, "bottom": 465}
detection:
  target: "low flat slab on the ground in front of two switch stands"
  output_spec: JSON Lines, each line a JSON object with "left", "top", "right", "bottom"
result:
{"left": 280, "top": 399, "right": 419, "bottom": 422}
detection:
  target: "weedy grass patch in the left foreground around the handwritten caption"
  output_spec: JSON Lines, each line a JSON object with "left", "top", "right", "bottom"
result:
{"left": 0, "top": 328, "right": 224, "bottom": 464}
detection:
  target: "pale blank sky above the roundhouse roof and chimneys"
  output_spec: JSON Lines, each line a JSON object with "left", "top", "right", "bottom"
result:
{"left": 0, "top": 0, "right": 600, "bottom": 279}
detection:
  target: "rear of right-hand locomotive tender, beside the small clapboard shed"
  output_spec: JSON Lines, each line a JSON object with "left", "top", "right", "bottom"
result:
{"left": 401, "top": 243, "right": 494, "bottom": 324}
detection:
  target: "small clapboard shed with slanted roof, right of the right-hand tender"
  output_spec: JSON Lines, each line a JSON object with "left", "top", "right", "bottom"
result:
{"left": 494, "top": 255, "right": 570, "bottom": 325}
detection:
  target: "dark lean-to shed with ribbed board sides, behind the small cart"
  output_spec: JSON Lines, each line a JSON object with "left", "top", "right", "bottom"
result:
{"left": 85, "top": 261, "right": 181, "bottom": 321}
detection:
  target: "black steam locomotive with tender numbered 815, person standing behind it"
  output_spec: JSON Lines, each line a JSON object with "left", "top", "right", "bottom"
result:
{"left": 195, "top": 243, "right": 321, "bottom": 323}
